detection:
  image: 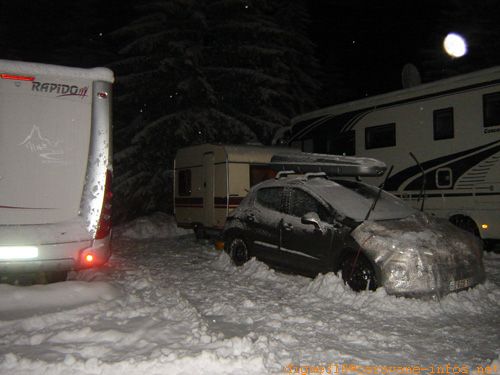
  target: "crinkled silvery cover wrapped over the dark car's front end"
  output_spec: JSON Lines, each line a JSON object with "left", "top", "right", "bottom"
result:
{"left": 351, "top": 213, "right": 484, "bottom": 297}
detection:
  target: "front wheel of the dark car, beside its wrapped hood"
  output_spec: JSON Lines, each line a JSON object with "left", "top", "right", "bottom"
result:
{"left": 341, "top": 253, "right": 379, "bottom": 292}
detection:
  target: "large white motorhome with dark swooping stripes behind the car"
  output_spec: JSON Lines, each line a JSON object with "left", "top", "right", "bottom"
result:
{"left": 282, "top": 67, "right": 500, "bottom": 245}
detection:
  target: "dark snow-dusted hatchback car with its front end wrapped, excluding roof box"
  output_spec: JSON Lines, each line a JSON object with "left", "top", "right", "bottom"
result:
{"left": 223, "top": 173, "right": 485, "bottom": 297}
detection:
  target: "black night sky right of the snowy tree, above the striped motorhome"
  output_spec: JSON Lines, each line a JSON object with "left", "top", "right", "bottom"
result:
{"left": 308, "top": 0, "right": 500, "bottom": 105}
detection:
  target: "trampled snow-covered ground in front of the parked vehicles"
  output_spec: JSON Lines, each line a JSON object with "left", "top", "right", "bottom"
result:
{"left": 0, "top": 215, "right": 500, "bottom": 375}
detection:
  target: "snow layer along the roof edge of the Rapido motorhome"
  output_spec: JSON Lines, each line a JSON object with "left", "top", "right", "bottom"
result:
{"left": 0, "top": 59, "right": 115, "bottom": 83}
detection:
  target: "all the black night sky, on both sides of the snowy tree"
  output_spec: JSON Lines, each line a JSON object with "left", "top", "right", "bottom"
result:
{"left": 0, "top": 0, "right": 500, "bottom": 106}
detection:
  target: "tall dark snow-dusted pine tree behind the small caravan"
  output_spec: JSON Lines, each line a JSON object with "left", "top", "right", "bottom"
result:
{"left": 112, "top": 0, "right": 318, "bottom": 218}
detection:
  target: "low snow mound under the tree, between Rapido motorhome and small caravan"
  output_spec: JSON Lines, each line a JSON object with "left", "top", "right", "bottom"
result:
{"left": 114, "top": 212, "right": 192, "bottom": 239}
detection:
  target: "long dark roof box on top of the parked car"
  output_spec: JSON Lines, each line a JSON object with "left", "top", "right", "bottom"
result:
{"left": 269, "top": 152, "right": 387, "bottom": 177}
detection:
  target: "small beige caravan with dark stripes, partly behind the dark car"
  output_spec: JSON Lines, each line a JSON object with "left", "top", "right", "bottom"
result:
{"left": 174, "top": 144, "right": 288, "bottom": 237}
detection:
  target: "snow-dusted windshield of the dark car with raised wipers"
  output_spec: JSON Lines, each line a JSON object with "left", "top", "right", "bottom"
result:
{"left": 310, "top": 180, "right": 416, "bottom": 221}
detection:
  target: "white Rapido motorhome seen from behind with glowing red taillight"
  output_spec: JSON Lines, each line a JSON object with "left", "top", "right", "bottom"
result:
{"left": 0, "top": 60, "right": 114, "bottom": 279}
